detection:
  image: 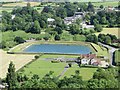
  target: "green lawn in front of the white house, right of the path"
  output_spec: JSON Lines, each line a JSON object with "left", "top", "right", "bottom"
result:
{"left": 61, "top": 64, "right": 97, "bottom": 80}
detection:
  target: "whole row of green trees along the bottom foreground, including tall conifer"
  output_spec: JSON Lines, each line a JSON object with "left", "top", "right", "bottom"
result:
{"left": 5, "top": 62, "right": 119, "bottom": 90}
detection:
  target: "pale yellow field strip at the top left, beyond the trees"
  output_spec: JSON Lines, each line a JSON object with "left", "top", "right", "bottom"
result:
{"left": 3, "top": 2, "right": 40, "bottom": 7}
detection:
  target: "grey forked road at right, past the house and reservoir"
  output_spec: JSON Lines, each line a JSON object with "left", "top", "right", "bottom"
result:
{"left": 98, "top": 42, "right": 118, "bottom": 66}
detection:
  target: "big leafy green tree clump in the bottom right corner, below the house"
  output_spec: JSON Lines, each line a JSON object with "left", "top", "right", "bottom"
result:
{"left": 88, "top": 68, "right": 118, "bottom": 89}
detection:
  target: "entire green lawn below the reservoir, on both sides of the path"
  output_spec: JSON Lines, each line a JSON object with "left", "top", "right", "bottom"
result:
{"left": 19, "top": 55, "right": 97, "bottom": 80}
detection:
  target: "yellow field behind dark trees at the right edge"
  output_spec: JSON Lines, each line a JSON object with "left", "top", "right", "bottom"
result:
{"left": 95, "top": 28, "right": 120, "bottom": 38}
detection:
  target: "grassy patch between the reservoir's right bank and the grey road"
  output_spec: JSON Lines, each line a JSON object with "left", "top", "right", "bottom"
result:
{"left": 91, "top": 43, "right": 108, "bottom": 56}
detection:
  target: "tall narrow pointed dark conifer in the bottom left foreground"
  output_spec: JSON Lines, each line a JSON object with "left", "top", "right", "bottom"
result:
{"left": 6, "top": 62, "right": 17, "bottom": 88}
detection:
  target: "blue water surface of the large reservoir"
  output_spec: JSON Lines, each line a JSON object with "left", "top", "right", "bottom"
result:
{"left": 23, "top": 44, "right": 92, "bottom": 54}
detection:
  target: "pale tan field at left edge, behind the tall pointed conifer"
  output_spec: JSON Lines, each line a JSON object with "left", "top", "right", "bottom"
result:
{"left": 0, "top": 49, "right": 34, "bottom": 78}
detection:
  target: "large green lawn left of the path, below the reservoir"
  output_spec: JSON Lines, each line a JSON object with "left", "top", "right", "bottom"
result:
{"left": 21, "top": 58, "right": 66, "bottom": 77}
